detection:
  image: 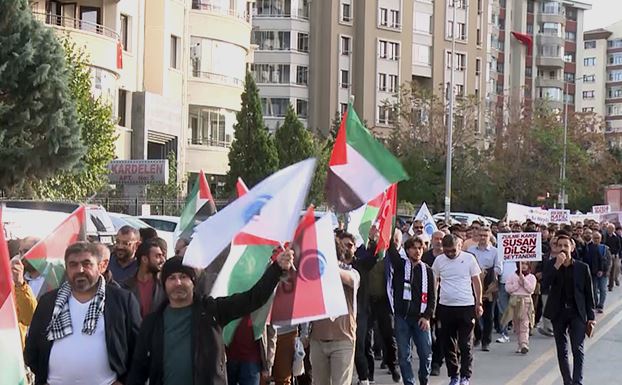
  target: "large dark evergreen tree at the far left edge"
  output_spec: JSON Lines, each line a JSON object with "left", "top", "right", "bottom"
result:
{"left": 0, "top": 0, "right": 85, "bottom": 194}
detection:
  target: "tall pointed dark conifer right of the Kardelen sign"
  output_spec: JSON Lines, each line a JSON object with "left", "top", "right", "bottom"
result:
{"left": 227, "top": 72, "right": 279, "bottom": 193}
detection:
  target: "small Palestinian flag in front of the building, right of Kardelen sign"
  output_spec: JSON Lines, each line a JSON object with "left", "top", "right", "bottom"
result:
{"left": 175, "top": 170, "right": 216, "bottom": 238}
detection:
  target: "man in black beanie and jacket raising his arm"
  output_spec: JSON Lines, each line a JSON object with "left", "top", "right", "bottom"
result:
{"left": 125, "top": 250, "right": 293, "bottom": 385}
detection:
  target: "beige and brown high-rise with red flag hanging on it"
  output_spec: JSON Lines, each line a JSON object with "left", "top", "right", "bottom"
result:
{"left": 488, "top": 0, "right": 591, "bottom": 125}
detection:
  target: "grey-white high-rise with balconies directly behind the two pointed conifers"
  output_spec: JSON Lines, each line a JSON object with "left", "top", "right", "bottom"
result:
{"left": 251, "top": 0, "right": 310, "bottom": 130}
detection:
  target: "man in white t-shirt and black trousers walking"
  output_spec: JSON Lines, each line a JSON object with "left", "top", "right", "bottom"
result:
{"left": 432, "top": 234, "right": 483, "bottom": 385}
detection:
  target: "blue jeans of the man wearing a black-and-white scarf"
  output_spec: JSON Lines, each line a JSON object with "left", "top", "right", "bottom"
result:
{"left": 395, "top": 316, "right": 432, "bottom": 385}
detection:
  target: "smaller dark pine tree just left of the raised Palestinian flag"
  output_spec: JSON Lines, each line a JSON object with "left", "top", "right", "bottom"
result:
{"left": 274, "top": 104, "right": 315, "bottom": 168}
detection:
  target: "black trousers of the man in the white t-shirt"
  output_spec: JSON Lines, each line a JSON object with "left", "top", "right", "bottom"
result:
{"left": 436, "top": 305, "right": 476, "bottom": 378}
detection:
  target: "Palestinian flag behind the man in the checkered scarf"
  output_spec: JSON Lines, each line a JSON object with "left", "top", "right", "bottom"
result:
{"left": 23, "top": 206, "right": 86, "bottom": 296}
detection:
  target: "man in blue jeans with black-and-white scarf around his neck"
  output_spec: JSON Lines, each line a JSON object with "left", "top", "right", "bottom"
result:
{"left": 388, "top": 237, "right": 436, "bottom": 385}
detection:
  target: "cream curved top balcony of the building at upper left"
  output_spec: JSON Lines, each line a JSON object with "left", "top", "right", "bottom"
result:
{"left": 32, "top": 11, "right": 120, "bottom": 76}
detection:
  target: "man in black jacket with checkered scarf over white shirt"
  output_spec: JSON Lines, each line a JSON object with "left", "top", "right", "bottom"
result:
{"left": 24, "top": 242, "right": 140, "bottom": 385}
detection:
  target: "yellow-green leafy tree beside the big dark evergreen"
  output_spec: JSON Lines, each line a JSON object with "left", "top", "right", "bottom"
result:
{"left": 35, "top": 38, "right": 119, "bottom": 200}
